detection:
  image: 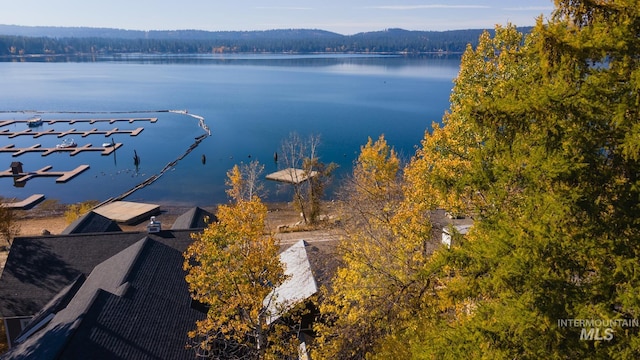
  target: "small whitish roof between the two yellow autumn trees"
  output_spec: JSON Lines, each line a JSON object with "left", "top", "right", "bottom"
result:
{"left": 263, "top": 240, "right": 318, "bottom": 324}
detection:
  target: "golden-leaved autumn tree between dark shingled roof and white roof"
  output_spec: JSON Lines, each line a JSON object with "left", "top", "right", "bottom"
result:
{"left": 184, "top": 166, "right": 298, "bottom": 359}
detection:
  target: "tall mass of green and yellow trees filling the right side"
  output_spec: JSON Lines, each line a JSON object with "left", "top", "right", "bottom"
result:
{"left": 378, "top": 0, "right": 640, "bottom": 359}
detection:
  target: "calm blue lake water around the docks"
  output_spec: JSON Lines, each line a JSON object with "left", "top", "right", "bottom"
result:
{"left": 0, "top": 55, "right": 460, "bottom": 205}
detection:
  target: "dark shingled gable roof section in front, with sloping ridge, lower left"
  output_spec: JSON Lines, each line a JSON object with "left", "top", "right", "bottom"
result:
{"left": 3, "top": 236, "right": 206, "bottom": 359}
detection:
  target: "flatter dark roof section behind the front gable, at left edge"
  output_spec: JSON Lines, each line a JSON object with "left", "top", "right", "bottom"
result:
{"left": 0, "top": 230, "right": 193, "bottom": 318}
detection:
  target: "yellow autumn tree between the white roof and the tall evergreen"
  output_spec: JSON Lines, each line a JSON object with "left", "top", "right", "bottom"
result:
{"left": 313, "top": 136, "right": 431, "bottom": 359}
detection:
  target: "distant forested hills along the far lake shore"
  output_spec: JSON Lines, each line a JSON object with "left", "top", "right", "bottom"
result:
{"left": 0, "top": 25, "right": 529, "bottom": 56}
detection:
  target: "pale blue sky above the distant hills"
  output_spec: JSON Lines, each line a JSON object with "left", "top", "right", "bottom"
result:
{"left": 0, "top": 0, "right": 553, "bottom": 35}
